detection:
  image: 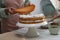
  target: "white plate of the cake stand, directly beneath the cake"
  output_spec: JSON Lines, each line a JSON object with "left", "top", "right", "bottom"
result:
{"left": 16, "top": 21, "right": 47, "bottom": 28}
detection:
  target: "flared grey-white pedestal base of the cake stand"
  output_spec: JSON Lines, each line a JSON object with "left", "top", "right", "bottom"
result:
{"left": 25, "top": 27, "right": 40, "bottom": 38}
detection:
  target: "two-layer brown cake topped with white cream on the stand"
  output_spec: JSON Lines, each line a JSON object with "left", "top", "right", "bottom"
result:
{"left": 19, "top": 14, "right": 45, "bottom": 24}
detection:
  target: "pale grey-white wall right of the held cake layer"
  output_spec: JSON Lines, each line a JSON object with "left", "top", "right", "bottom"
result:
{"left": 30, "top": 0, "right": 41, "bottom": 14}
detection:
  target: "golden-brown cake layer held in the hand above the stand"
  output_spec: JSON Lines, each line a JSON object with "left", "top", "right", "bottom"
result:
{"left": 13, "top": 4, "right": 35, "bottom": 15}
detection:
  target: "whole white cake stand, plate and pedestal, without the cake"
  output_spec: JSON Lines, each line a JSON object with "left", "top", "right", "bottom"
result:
{"left": 16, "top": 21, "right": 47, "bottom": 37}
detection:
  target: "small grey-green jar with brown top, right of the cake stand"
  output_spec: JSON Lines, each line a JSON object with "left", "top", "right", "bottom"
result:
{"left": 49, "top": 22, "right": 59, "bottom": 35}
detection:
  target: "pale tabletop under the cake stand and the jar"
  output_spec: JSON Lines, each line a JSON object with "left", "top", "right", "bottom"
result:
{"left": 0, "top": 29, "right": 60, "bottom": 40}
